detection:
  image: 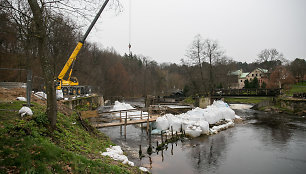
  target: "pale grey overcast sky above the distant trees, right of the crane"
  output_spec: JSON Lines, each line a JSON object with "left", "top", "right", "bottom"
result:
{"left": 88, "top": 0, "right": 306, "bottom": 63}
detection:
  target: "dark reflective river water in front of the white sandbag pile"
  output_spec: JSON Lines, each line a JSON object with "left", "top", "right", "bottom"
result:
{"left": 101, "top": 105, "right": 306, "bottom": 174}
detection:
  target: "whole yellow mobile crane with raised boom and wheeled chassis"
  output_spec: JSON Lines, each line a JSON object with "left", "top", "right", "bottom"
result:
{"left": 56, "top": 0, "right": 109, "bottom": 95}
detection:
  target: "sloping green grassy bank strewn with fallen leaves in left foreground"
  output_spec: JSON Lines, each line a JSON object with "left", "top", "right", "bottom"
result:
{"left": 0, "top": 101, "right": 141, "bottom": 173}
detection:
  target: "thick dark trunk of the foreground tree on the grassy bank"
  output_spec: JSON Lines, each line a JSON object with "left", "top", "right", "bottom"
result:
{"left": 28, "top": 0, "right": 57, "bottom": 128}
